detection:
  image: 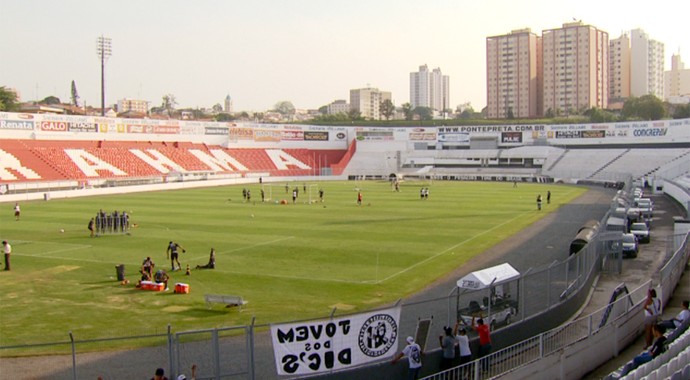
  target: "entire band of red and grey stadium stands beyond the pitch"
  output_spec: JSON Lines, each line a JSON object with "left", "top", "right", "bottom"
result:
{"left": 0, "top": 139, "right": 690, "bottom": 188}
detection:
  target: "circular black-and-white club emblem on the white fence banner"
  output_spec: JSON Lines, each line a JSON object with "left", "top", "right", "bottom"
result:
{"left": 359, "top": 314, "right": 398, "bottom": 358}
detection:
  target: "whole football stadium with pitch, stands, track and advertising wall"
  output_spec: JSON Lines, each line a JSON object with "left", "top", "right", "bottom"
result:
{"left": 0, "top": 112, "right": 690, "bottom": 379}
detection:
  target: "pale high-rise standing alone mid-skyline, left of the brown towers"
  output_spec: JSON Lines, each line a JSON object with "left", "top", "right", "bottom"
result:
{"left": 410, "top": 65, "right": 450, "bottom": 112}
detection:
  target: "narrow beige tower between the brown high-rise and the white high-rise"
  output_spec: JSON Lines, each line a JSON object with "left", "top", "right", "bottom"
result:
{"left": 609, "top": 33, "right": 630, "bottom": 103}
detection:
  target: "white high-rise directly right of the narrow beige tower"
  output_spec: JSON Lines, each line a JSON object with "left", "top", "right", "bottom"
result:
{"left": 630, "top": 29, "right": 664, "bottom": 99}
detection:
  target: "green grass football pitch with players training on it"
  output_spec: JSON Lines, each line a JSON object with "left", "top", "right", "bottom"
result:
{"left": 0, "top": 181, "right": 585, "bottom": 345}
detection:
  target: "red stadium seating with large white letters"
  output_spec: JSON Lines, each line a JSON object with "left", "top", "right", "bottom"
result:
{"left": 0, "top": 140, "right": 347, "bottom": 181}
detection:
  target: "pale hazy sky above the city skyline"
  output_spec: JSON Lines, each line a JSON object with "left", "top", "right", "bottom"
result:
{"left": 0, "top": 0, "right": 690, "bottom": 111}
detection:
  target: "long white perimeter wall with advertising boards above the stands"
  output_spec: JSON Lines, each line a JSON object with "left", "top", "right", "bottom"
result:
{"left": 0, "top": 112, "right": 690, "bottom": 151}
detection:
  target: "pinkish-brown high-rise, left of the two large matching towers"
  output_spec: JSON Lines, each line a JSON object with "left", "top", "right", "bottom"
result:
{"left": 486, "top": 28, "right": 541, "bottom": 119}
